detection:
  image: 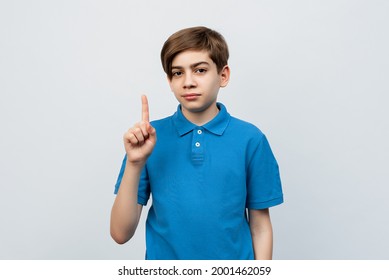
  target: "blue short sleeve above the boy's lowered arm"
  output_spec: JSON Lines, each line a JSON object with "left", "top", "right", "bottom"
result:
{"left": 246, "top": 134, "right": 284, "bottom": 209}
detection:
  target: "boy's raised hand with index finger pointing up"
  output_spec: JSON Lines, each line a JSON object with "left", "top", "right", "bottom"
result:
{"left": 123, "top": 95, "right": 157, "bottom": 166}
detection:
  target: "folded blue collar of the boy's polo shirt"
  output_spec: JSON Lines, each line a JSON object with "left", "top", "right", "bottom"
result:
{"left": 172, "top": 102, "right": 231, "bottom": 136}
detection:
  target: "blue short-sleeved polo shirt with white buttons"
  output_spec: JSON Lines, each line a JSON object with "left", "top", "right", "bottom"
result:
{"left": 115, "top": 103, "right": 283, "bottom": 260}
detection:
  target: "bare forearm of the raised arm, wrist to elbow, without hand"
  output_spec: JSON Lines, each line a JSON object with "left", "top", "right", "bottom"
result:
{"left": 110, "top": 164, "right": 142, "bottom": 244}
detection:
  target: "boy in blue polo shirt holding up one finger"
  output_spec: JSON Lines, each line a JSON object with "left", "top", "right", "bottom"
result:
{"left": 111, "top": 27, "right": 283, "bottom": 259}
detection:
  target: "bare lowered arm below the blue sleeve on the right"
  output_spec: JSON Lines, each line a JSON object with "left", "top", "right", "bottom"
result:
{"left": 249, "top": 209, "right": 273, "bottom": 260}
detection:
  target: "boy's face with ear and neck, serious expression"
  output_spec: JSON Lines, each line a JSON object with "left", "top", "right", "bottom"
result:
{"left": 169, "top": 50, "right": 230, "bottom": 120}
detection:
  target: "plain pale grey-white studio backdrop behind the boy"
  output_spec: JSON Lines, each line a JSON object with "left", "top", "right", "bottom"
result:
{"left": 0, "top": 0, "right": 389, "bottom": 259}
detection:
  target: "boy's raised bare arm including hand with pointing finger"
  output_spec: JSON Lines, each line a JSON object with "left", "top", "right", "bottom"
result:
{"left": 110, "top": 96, "right": 157, "bottom": 244}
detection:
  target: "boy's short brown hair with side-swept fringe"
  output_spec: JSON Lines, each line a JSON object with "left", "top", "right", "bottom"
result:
{"left": 161, "top": 26, "right": 229, "bottom": 79}
